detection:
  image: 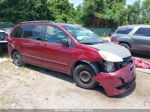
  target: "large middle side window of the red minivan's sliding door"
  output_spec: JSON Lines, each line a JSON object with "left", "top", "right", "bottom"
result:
{"left": 22, "top": 25, "right": 46, "bottom": 40}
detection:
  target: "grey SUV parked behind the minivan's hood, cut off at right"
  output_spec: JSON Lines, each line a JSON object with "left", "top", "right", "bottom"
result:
{"left": 111, "top": 25, "right": 150, "bottom": 53}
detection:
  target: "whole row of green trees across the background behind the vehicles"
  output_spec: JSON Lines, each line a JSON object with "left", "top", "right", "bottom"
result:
{"left": 0, "top": 0, "right": 150, "bottom": 27}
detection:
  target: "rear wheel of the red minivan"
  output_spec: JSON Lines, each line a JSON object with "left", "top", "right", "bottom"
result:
{"left": 12, "top": 51, "right": 24, "bottom": 67}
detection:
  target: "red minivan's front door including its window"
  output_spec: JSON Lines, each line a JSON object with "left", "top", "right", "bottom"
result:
{"left": 42, "top": 25, "right": 71, "bottom": 73}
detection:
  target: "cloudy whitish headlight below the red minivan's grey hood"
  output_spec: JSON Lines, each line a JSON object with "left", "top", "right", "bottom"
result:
{"left": 98, "top": 51, "right": 123, "bottom": 62}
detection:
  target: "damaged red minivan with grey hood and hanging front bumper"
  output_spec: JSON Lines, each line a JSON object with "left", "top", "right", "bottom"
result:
{"left": 7, "top": 21, "right": 136, "bottom": 96}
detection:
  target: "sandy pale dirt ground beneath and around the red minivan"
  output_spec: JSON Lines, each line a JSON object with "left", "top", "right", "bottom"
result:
{"left": 0, "top": 50, "right": 150, "bottom": 109}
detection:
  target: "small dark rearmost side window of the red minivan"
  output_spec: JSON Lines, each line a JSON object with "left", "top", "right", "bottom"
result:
{"left": 11, "top": 26, "right": 23, "bottom": 38}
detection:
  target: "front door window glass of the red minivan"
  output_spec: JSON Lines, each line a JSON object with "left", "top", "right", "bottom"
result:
{"left": 45, "top": 25, "right": 68, "bottom": 44}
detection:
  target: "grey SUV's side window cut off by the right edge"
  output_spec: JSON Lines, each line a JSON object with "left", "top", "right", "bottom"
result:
{"left": 134, "top": 28, "right": 150, "bottom": 37}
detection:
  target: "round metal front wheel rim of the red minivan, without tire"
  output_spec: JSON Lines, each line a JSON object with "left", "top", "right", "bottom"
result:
{"left": 79, "top": 71, "right": 92, "bottom": 83}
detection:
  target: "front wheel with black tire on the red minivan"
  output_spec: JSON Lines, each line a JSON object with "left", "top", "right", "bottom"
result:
{"left": 73, "top": 64, "right": 97, "bottom": 89}
